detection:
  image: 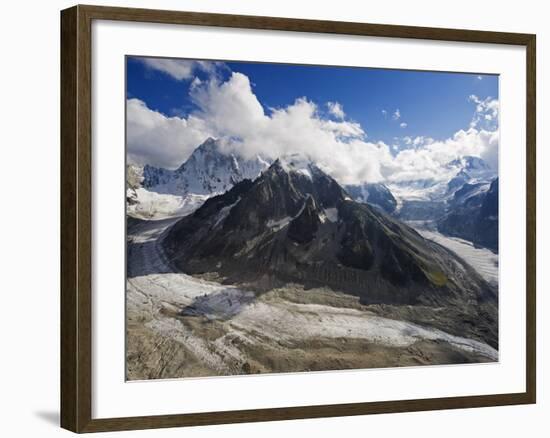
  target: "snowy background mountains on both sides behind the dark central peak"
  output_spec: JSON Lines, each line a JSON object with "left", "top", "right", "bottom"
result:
{"left": 127, "top": 138, "right": 498, "bottom": 252}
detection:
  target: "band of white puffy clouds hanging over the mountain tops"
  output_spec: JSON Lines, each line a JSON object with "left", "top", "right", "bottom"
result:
{"left": 127, "top": 67, "right": 498, "bottom": 184}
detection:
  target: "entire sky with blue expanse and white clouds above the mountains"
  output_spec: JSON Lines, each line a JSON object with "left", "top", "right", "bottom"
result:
{"left": 126, "top": 57, "right": 499, "bottom": 183}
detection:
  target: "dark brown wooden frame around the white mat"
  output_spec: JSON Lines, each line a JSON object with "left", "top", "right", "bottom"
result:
{"left": 61, "top": 6, "right": 536, "bottom": 433}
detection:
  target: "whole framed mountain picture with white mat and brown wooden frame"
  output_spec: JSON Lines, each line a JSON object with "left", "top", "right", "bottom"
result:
{"left": 61, "top": 6, "right": 536, "bottom": 432}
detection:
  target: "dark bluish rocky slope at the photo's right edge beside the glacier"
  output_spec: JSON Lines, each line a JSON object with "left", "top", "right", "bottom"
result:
{"left": 437, "top": 178, "right": 498, "bottom": 252}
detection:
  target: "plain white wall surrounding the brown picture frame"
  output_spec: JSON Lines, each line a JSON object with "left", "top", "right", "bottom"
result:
{"left": 0, "top": 0, "right": 550, "bottom": 438}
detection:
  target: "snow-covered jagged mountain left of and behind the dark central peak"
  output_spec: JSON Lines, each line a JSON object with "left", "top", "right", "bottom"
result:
{"left": 126, "top": 138, "right": 269, "bottom": 219}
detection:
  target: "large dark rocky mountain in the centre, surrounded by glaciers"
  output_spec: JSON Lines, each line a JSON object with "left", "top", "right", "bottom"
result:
{"left": 163, "top": 157, "right": 498, "bottom": 345}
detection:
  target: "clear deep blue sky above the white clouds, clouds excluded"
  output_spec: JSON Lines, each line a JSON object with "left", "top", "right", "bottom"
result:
{"left": 127, "top": 58, "right": 498, "bottom": 143}
